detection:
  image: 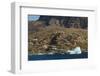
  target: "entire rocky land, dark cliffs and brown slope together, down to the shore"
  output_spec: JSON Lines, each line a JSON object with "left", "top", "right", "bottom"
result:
{"left": 28, "top": 16, "right": 88, "bottom": 54}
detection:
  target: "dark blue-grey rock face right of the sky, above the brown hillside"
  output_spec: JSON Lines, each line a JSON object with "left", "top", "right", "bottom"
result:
{"left": 39, "top": 16, "right": 88, "bottom": 28}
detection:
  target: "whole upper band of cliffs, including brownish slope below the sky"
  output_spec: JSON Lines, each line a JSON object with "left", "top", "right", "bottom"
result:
{"left": 28, "top": 16, "right": 88, "bottom": 31}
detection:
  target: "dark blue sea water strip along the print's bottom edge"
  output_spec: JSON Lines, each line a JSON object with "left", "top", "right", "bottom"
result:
{"left": 28, "top": 52, "right": 88, "bottom": 61}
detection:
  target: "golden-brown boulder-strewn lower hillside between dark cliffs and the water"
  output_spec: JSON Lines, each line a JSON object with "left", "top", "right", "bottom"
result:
{"left": 28, "top": 26, "right": 88, "bottom": 54}
